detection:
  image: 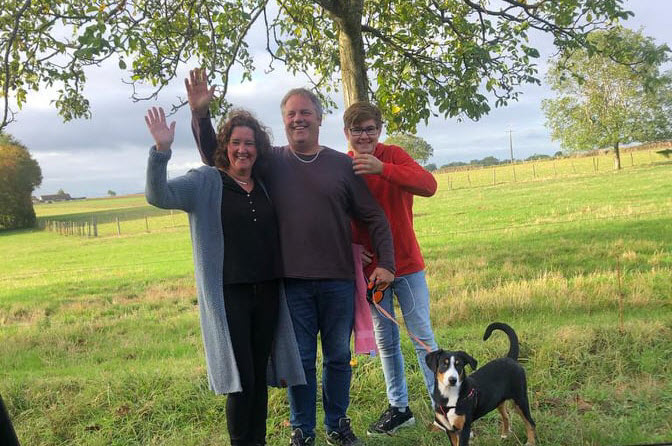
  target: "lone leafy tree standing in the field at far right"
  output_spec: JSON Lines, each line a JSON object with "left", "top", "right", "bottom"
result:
{"left": 542, "top": 28, "right": 672, "bottom": 169}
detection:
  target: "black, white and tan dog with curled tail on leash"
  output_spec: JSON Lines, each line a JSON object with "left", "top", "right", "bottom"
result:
{"left": 425, "top": 322, "right": 536, "bottom": 446}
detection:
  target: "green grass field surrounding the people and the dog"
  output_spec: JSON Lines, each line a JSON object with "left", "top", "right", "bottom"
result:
{"left": 0, "top": 157, "right": 672, "bottom": 446}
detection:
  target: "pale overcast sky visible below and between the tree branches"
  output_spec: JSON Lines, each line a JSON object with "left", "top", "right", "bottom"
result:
{"left": 6, "top": 0, "right": 672, "bottom": 197}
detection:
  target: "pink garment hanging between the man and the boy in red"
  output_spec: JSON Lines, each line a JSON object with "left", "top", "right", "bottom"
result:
{"left": 352, "top": 243, "right": 378, "bottom": 356}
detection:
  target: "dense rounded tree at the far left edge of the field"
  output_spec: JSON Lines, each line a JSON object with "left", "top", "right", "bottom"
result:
{"left": 0, "top": 133, "right": 42, "bottom": 229}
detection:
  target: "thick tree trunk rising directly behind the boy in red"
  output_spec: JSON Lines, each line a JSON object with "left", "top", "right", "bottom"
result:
{"left": 334, "top": 0, "right": 369, "bottom": 107}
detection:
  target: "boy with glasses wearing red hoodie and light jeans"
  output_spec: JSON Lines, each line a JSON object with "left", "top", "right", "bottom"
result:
{"left": 343, "top": 102, "right": 437, "bottom": 435}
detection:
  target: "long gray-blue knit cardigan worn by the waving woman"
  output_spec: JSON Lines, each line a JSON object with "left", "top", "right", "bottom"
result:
{"left": 145, "top": 147, "right": 306, "bottom": 394}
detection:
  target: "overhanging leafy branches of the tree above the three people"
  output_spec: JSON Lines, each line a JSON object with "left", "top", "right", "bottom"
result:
{"left": 0, "top": 0, "right": 632, "bottom": 133}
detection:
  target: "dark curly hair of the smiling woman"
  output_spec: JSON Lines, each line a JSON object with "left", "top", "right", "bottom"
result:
{"left": 215, "top": 108, "right": 271, "bottom": 169}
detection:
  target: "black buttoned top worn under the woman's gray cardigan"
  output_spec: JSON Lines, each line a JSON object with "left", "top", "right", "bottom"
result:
{"left": 221, "top": 172, "right": 282, "bottom": 284}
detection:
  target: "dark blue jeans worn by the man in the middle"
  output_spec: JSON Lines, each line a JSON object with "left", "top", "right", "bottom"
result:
{"left": 285, "top": 279, "right": 355, "bottom": 437}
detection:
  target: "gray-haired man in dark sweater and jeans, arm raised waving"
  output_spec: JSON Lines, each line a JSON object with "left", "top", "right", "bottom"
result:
{"left": 186, "top": 70, "right": 394, "bottom": 446}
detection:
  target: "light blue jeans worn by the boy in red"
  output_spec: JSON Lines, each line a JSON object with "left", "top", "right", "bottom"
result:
{"left": 371, "top": 271, "right": 437, "bottom": 407}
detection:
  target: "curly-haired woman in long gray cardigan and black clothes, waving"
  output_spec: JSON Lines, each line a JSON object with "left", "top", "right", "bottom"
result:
{"left": 145, "top": 107, "right": 305, "bottom": 446}
